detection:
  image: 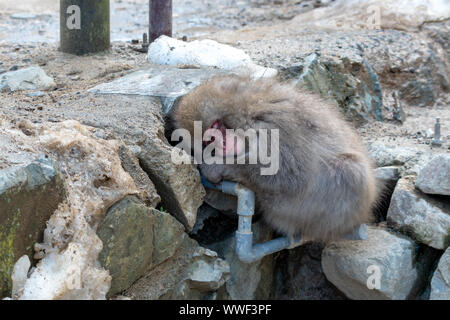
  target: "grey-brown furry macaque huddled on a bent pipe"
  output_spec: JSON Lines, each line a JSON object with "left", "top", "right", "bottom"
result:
{"left": 172, "top": 76, "right": 379, "bottom": 242}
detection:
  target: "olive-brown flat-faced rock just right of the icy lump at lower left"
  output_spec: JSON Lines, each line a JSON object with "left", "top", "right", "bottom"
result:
{"left": 97, "top": 196, "right": 153, "bottom": 295}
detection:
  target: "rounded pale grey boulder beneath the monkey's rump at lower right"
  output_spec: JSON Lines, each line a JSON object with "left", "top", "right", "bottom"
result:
{"left": 322, "top": 227, "right": 436, "bottom": 300}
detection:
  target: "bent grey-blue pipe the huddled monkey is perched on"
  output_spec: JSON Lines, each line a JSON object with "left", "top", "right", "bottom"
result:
{"left": 201, "top": 176, "right": 368, "bottom": 263}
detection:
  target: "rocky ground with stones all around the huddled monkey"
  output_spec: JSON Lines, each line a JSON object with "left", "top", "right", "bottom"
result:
{"left": 0, "top": 0, "right": 450, "bottom": 299}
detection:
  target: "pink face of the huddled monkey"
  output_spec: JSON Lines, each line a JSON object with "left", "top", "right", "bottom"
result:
{"left": 203, "top": 120, "right": 245, "bottom": 157}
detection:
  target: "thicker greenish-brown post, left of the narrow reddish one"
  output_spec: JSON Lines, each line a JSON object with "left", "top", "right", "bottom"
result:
{"left": 60, "top": 0, "right": 110, "bottom": 55}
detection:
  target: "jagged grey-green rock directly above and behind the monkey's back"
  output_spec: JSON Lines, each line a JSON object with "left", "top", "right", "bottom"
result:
{"left": 285, "top": 53, "right": 383, "bottom": 123}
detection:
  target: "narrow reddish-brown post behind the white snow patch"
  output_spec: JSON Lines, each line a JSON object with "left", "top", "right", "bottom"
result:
{"left": 148, "top": 0, "right": 172, "bottom": 43}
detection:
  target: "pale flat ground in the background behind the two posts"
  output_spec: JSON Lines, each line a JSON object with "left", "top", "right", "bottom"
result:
{"left": 0, "top": 0, "right": 331, "bottom": 43}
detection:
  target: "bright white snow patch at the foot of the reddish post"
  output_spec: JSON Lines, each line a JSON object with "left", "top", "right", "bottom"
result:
{"left": 148, "top": 36, "right": 277, "bottom": 78}
